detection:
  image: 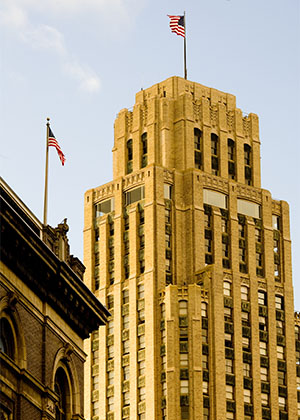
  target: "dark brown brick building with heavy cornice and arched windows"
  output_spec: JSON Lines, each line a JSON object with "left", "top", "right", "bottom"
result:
{"left": 0, "top": 179, "right": 109, "bottom": 420}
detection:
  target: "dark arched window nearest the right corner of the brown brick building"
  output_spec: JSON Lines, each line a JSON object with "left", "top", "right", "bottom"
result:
{"left": 54, "top": 367, "right": 72, "bottom": 420}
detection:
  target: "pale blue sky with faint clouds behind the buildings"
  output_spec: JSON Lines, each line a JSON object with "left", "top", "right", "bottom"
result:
{"left": 0, "top": 0, "right": 300, "bottom": 310}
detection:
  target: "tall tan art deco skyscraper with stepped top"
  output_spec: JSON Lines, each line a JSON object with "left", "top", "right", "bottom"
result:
{"left": 84, "top": 77, "right": 300, "bottom": 420}
